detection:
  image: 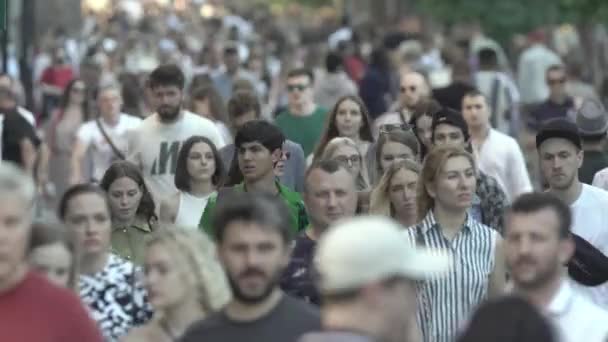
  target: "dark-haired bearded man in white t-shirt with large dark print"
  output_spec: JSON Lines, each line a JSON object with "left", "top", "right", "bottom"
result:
{"left": 128, "top": 64, "right": 224, "bottom": 201}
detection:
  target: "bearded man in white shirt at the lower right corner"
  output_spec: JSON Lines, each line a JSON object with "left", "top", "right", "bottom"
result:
{"left": 504, "top": 192, "right": 608, "bottom": 342}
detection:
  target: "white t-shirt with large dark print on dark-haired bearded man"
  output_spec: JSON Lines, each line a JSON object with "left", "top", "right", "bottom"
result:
{"left": 128, "top": 111, "right": 225, "bottom": 203}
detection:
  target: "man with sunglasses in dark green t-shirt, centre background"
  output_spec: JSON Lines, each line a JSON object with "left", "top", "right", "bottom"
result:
{"left": 275, "top": 68, "right": 327, "bottom": 156}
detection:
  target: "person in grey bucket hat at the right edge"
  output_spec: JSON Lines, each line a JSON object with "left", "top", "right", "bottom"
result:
{"left": 576, "top": 99, "right": 608, "bottom": 184}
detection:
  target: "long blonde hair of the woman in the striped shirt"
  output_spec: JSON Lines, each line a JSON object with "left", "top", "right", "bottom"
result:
{"left": 416, "top": 146, "right": 475, "bottom": 221}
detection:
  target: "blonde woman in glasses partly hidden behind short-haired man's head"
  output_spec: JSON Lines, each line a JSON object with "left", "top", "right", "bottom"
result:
{"left": 321, "top": 137, "right": 369, "bottom": 191}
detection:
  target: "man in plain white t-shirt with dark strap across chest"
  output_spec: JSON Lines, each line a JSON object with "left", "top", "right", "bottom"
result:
{"left": 70, "top": 84, "right": 141, "bottom": 184}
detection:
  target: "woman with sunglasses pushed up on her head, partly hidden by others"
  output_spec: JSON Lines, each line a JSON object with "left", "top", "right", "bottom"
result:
{"left": 370, "top": 128, "right": 420, "bottom": 183}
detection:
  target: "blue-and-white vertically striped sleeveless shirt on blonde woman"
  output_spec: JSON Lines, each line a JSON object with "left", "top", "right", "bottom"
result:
{"left": 406, "top": 210, "right": 498, "bottom": 342}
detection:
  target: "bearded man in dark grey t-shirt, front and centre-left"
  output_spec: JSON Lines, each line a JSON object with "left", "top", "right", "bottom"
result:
{"left": 181, "top": 192, "right": 320, "bottom": 342}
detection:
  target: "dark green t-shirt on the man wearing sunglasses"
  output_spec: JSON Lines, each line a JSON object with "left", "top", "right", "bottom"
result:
{"left": 275, "top": 107, "right": 327, "bottom": 157}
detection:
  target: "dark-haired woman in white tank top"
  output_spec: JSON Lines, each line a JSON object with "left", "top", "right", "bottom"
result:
{"left": 160, "top": 136, "right": 224, "bottom": 229}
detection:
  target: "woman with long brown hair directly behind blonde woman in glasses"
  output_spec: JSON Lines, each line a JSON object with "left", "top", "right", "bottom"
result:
{"left": 313, "top": 95, "right": 374, "bottom": 160}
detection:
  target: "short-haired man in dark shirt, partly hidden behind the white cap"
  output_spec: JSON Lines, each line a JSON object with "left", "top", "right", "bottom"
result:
{"left": 281, "top": 160, "right": 357, "bottom": 305}
